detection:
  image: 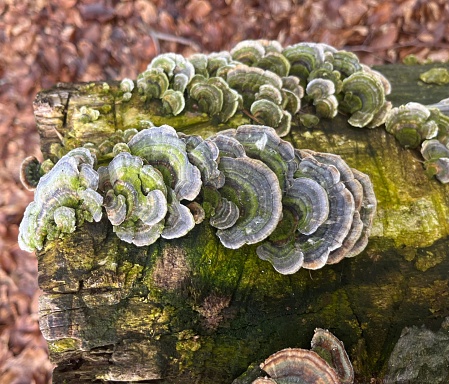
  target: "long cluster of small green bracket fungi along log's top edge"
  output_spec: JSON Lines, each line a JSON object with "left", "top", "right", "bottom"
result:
{"left": 120, "top": 40, "right": 391, "bottom": 136}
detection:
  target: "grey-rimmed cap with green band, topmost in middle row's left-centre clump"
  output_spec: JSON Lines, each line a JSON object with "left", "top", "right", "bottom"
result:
{"left": 128, "top": 125, "right": 201, "bottom": 200}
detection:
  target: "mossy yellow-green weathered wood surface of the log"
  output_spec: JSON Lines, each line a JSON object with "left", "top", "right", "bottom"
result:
{"left": 35, "top": 61, "right": 449, "bottom": 383}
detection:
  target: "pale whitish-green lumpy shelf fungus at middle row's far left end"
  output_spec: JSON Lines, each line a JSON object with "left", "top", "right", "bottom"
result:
{"left": 19, "top": 148, "right": 103, "bottom": 252}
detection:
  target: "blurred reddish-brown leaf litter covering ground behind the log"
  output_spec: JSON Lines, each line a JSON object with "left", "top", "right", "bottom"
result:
{"left": 0, "top": 0, "right": 449, "bottom": 384}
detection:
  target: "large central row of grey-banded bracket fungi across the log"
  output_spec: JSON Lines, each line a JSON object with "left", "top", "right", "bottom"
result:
{"left": 20, "top": 125, "right": 376, "bottom": 274}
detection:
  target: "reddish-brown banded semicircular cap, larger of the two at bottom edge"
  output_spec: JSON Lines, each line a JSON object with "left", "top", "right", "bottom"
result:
{"left": 260, "top": 348, "right": 340, "bottom": 384}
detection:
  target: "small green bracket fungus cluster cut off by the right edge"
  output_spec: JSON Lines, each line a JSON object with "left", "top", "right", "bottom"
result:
{"left": 385, "top": 99, "right": 449, "bottom": 183}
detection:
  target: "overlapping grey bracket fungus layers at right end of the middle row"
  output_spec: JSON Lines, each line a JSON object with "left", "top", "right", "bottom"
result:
{"left": 257, "top": 146, "right": 376, "bottom": 274}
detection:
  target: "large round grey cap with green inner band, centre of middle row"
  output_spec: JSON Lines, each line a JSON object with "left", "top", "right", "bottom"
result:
{"left": 217, "top": 157, "right": 282, "bottom": 249}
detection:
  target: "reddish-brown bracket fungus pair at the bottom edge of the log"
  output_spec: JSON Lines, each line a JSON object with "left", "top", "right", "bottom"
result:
{"left": 252, "top": 328, "right": 354, "bottom": 384}
